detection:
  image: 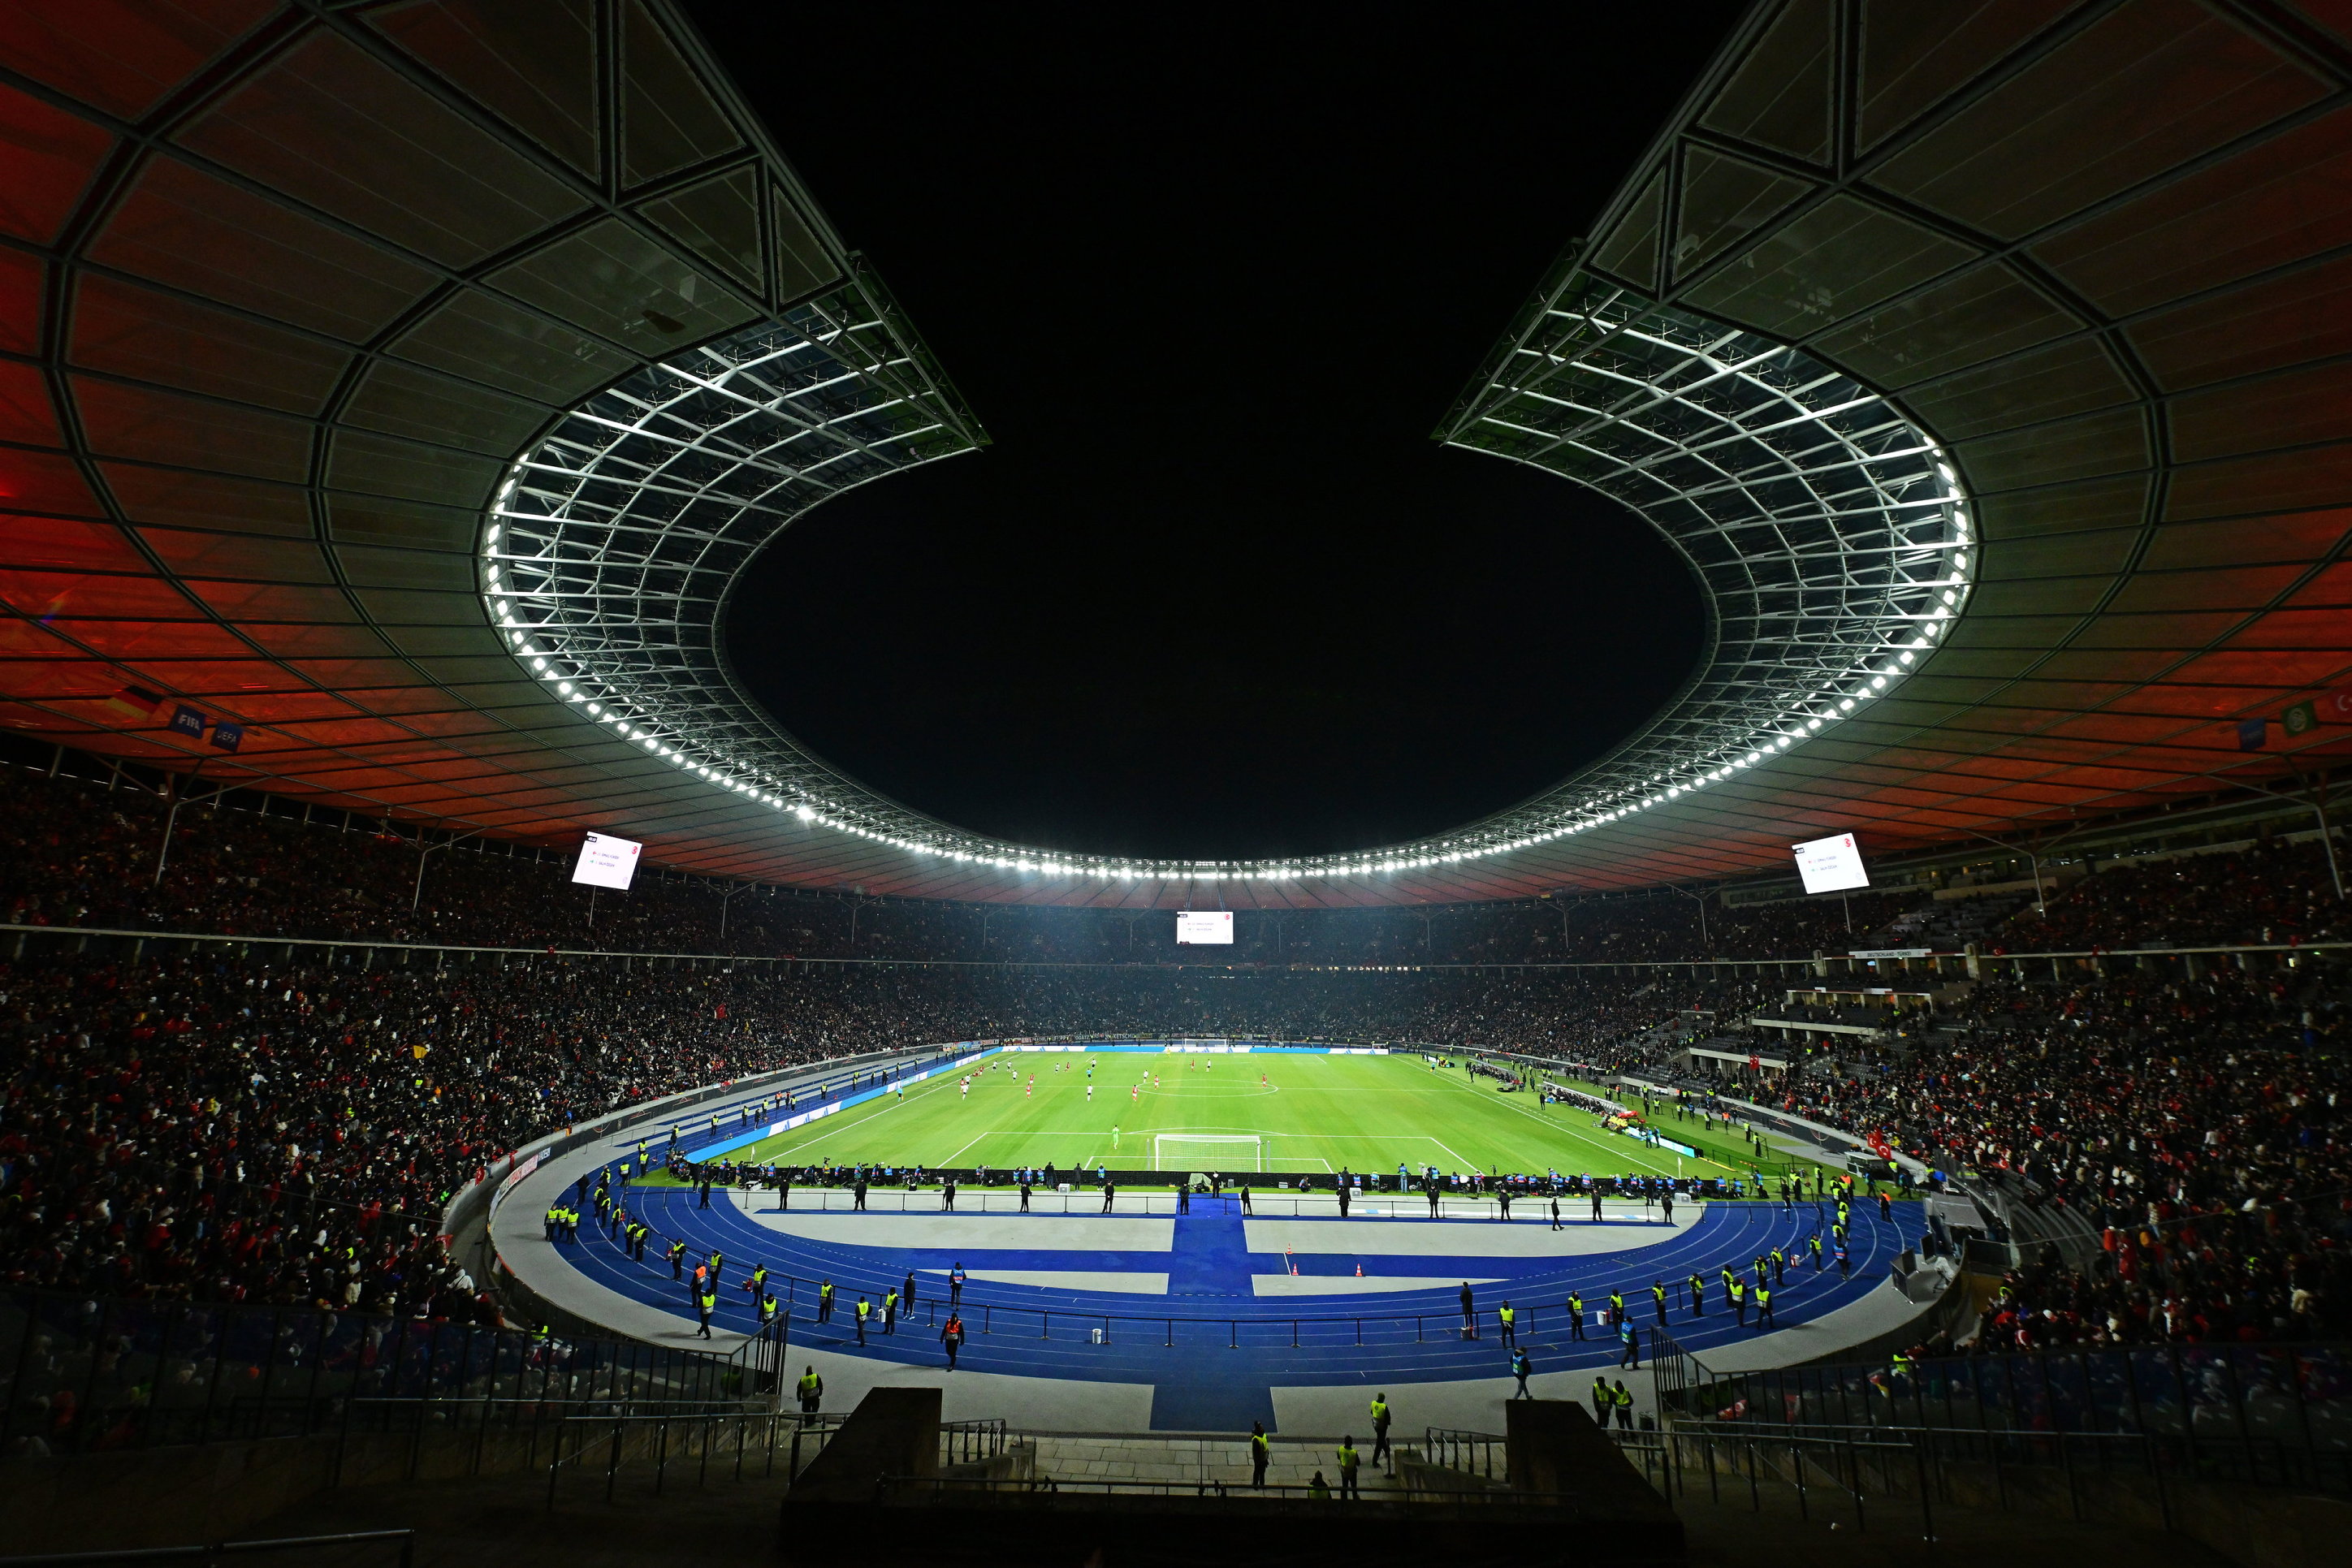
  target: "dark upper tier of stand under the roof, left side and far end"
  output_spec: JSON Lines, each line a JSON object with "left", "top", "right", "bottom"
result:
{"left": 0, "top": 764, "right": 1903, "bottom": 969}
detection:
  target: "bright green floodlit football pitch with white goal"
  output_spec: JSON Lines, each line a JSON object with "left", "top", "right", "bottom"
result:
{"left": 696, "top": 1051, "right": 1796, "bottom": 1177}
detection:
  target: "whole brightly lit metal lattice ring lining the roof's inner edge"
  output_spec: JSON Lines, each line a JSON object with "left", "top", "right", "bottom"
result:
{"left": 482, "top": 270, "right": 1969, "bottom": 879}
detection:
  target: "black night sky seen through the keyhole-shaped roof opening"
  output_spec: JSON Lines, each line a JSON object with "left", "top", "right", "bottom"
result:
{"left": 690, "top": 0, "right": 1740, "bottom": 858}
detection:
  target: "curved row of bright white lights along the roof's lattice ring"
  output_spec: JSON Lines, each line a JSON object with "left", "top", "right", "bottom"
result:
{"left": 482, "top": 447, "right": 1971, "bottom": 882}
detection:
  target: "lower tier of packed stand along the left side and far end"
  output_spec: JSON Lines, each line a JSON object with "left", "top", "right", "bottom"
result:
{"left": 0, "top": 954, "right": 1778, "bottom": 1316}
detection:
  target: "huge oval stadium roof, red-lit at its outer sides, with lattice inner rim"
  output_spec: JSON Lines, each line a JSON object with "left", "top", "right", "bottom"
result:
{"left": 0, "top": 0, "right": 2352, "bottom": 907}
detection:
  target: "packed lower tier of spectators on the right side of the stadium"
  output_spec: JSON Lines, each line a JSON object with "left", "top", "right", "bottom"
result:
{"left": 1783, "top": 964, "right": 2352, "bottom": 1350}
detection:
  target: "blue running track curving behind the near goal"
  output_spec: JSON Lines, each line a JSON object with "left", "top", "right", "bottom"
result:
{"left": 557, "top": 1187, "right": 1922, "bottom": 1432}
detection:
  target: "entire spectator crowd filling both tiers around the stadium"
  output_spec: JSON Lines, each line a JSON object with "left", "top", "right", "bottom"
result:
{"left": 0, "top": 769, "right": 2352, "bottom": 1347}
